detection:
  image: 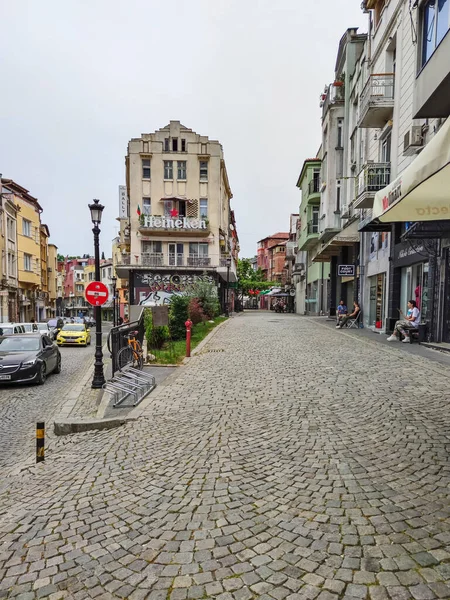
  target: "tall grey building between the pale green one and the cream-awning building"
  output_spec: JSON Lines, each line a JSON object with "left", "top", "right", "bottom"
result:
{"left": 312, "top": 28, "right": 367, "bottom": 316}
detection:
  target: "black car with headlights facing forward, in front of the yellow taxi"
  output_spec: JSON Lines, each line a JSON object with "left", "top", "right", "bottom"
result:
{"left": 0, "top": 333, "right": 61, "bottom": 384}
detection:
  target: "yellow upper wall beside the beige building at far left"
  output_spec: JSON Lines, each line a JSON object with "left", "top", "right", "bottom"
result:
{"left": 15, "top": 196, "right": 41, "bottom": 288}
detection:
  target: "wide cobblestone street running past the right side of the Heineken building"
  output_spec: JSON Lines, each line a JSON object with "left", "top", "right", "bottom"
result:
{"left": 0, "top": 313, "right": 450, "bottom": 600}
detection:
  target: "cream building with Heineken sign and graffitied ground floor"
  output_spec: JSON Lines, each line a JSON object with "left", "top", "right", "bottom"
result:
{"left": 116, "top": 121, "right": 239, "bottom": 306}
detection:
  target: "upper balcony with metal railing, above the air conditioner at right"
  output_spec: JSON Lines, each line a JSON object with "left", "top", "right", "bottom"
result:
{"left": 358, "top": 73, "right": 395, "bottom": 128}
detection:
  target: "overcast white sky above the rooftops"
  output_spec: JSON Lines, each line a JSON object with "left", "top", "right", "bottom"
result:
{"left": 0, "top": 0, "right": 366, "bottom": 257}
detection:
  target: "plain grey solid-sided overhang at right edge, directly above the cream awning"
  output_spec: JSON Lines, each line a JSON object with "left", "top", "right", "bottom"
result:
{"left": 413, "top": 29, "right": 450, "bottom": 119}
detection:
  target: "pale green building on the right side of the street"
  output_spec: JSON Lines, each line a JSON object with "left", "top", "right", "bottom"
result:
{"left": 296, "top": 157, "right": 330, "bottom": 315}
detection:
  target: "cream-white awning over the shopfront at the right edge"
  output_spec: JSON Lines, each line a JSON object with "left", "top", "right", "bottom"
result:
{"left": 372, "top": 118, "right": 450, "bottom": 223}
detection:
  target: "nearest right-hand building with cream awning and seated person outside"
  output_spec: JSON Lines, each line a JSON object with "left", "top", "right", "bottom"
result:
{"left": 356, "top": 0, "right": 450, "bottom": 341}
